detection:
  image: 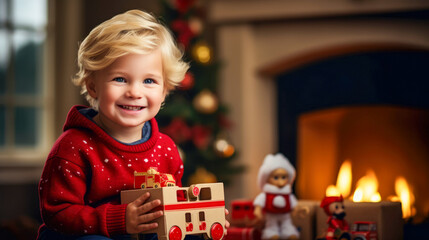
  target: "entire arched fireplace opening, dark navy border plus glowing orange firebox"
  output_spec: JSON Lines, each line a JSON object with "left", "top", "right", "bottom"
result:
{"left": 276, "top": 49, "right": 429, "bottom": 222}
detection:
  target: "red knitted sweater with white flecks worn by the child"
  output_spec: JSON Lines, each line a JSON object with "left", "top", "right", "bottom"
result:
{"left": 39, "top": 106, "right": 183, "bottom": 236}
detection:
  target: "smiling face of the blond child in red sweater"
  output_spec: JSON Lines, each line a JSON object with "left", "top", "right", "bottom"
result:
{"left": 87, "top": 51, "right": 166, "bottom": 132}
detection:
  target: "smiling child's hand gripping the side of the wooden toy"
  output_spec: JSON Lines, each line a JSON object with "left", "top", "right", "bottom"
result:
{"left": 125, "top": 192, "right": 163, "bottom": 234}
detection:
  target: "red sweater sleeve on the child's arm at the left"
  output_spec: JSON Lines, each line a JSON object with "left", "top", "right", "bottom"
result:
{"left": 39, "top": 156, "right": 126, "bottom": 236}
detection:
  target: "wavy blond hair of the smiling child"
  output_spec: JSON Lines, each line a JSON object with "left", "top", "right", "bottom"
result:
{"left": 73, "top": 10, "right": 189, "bottom": 109}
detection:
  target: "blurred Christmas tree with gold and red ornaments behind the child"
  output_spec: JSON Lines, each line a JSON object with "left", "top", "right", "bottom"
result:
{"left": 157, "top": 0, "right": 243, "bottom": 184}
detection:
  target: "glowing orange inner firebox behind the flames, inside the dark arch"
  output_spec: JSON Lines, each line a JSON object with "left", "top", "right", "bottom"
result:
{"left": 296, "top": 106, "right": 429, "bottom": 221}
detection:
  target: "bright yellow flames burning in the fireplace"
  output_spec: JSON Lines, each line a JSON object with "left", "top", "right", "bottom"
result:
{"left": 326, "top": 160, "right": 416, "bottom": 218}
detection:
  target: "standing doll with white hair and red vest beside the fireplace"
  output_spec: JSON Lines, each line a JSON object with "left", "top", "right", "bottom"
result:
{"left": 253, "top": 153, "right": 299, "bottom": 239}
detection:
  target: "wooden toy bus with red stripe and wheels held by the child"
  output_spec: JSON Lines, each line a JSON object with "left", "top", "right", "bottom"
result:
{"left": 121, "top": 172, "right": 225, "bottom": 240}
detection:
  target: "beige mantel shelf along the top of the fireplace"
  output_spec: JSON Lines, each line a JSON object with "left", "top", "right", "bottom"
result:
{"left": 209, "top": 0, "right": 429, "bottom": 24}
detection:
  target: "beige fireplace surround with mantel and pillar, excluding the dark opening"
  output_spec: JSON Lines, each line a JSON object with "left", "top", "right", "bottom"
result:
{"left": 209, "top": 0, "right": 429, "bottom": 201}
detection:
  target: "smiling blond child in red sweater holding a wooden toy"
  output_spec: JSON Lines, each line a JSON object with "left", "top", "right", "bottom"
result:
{"left": 38, "top": 10, "right": 189, "bottom": 239}
